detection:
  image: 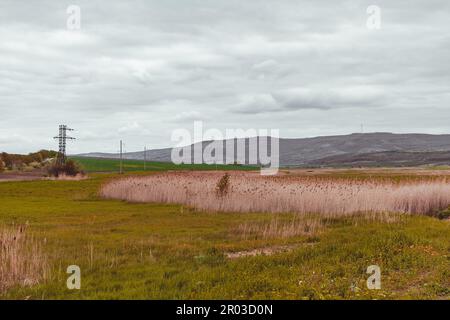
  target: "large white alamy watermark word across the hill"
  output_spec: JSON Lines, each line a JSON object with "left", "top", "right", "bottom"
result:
{"left": 171, "top": 121, "right": 280, "bottom": 175}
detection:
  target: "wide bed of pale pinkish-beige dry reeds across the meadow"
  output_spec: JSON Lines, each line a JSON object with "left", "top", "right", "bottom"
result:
{"left": 100, "top": 172, "right": 450, "bottom": 218}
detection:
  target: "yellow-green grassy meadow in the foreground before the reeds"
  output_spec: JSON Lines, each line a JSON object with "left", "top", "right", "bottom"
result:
{"left": 0, "top": 170, "right": 450, "bottom": 299}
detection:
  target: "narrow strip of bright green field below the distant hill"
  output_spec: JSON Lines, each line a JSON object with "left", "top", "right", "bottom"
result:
{"left": 70, "top": 157, "right": 259, "bottom": 172}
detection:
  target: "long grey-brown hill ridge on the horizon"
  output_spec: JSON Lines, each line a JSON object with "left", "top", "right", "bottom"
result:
{"left": 74, "top": 132, "right": 450, "bottom": 166}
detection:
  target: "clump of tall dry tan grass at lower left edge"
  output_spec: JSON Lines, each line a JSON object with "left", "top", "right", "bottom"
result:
{"left": 0, "top": 226, "right": 48, "bottom": 293}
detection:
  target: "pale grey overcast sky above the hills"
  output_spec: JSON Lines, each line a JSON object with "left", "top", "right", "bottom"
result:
{"left": 0, "top": 0, "right": 450, "bottom": 153}
